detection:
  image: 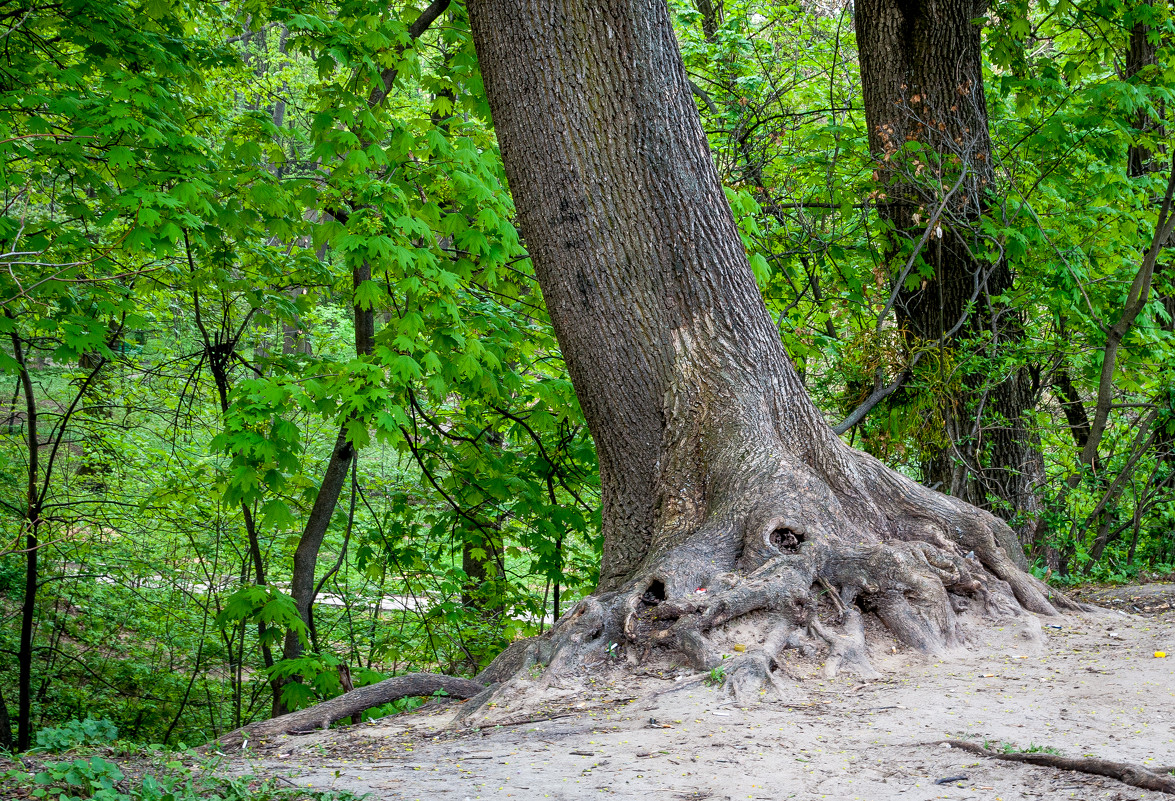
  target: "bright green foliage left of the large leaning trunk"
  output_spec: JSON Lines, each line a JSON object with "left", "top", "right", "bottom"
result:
{"left": 0, "top": 1, "right": 599, "bottom": 741}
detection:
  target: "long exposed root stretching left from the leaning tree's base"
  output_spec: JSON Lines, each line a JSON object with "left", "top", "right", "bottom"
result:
{"left": 215, "top": 673, "right": 485, "bottom": 748}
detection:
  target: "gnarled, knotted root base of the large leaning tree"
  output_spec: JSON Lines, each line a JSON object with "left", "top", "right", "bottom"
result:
{"left": 465, "top": 439, "right": 1090, "bottom": 716}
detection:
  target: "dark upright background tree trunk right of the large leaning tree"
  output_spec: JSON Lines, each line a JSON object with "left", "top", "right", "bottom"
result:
{"left": 855, "top": 0, "right": 1045, "bottom": 545}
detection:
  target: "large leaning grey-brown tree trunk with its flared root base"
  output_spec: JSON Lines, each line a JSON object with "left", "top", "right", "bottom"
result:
{"left": 469, "top": 0, "right": 1071, "bottom": 691}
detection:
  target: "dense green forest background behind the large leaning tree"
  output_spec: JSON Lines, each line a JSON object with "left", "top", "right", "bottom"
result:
{"left": 0, "top": 0, "right": 1175, "bottom": 748}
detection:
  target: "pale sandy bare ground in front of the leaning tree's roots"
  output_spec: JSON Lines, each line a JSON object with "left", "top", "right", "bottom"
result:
{"left": 233, "top": 585, "right": 1175, "bottom": 801}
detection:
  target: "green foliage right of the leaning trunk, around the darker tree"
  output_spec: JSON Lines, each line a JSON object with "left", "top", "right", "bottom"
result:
{"left": 671, "top": 0, "right": 1175, "bottom": 580}
